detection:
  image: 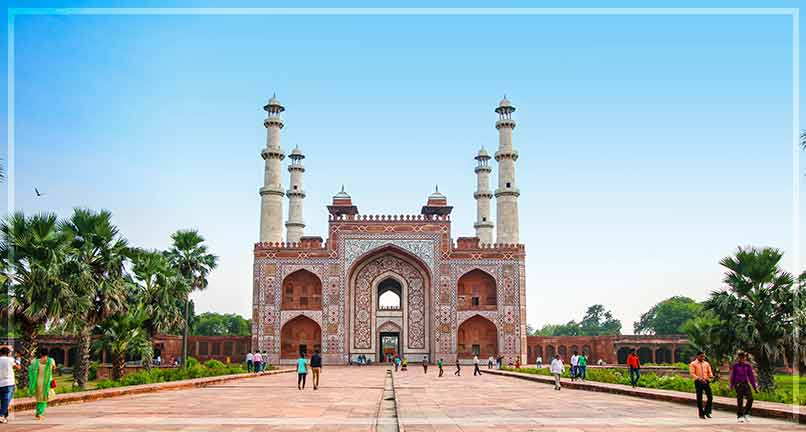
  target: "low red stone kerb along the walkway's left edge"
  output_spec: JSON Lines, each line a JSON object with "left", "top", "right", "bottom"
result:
{"left": 10, "top": 369, "right": 294, "bottom": 412}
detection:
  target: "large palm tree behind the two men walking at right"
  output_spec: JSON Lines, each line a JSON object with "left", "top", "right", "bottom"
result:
{"left": 704, "top": 247, "right": 795, "bottom": 390}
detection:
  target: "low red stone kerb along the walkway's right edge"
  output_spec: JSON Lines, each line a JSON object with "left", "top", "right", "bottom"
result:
{"left": 485, "top": 370, "right": 806, "bottom": 424}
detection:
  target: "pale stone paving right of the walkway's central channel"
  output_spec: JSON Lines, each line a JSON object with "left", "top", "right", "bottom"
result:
{"left": 395, "top": 367, "right": 806, "bottom": 432}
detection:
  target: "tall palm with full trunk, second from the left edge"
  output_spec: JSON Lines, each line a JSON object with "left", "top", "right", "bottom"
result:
{"left": 62, "top": 209, "right": 131, "bottom": 389}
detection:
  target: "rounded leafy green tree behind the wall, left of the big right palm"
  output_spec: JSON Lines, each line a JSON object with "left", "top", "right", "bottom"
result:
{"left": 633, "top": 296, "right": 702, "bottom": 335}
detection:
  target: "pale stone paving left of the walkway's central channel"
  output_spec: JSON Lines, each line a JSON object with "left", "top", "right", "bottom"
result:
{"left": 0, "top": 367, "right": 386, "bottom": 432}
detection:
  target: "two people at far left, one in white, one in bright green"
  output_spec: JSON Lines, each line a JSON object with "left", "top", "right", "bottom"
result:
{"left": 0, "top": 347, "right": 56, "bottom": 423}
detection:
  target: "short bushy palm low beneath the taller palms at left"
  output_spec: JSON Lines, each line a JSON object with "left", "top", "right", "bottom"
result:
{"left": 94, "top": 305, "right": 152, "bottom": 380}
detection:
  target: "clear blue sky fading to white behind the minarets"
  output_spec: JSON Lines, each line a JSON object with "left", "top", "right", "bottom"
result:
{"left": 0, "top": 1, "right": 806, "bottom": 332}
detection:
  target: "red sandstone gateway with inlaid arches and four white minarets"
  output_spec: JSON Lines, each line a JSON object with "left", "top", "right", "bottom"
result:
{"left": 252, "top": 97, "right": 527, "bottom": 364}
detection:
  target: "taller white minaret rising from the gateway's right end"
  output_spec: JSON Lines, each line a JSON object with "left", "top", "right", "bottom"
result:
{"left": 495, "top": 96, "right": 520, "bottom": 244}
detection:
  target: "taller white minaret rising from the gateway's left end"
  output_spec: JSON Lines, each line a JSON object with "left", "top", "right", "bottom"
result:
{"left": 260, "top": 96, "right": 285, "bottom": 242}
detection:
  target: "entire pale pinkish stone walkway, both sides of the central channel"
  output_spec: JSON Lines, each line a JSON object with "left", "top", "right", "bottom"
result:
{"left": 0, "top": 365, "right": 806, "bottom": 432}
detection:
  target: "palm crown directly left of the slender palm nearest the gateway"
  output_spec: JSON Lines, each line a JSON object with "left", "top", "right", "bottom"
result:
{"left": 131, "top": 250, "right": 189, "bottom": 337}
